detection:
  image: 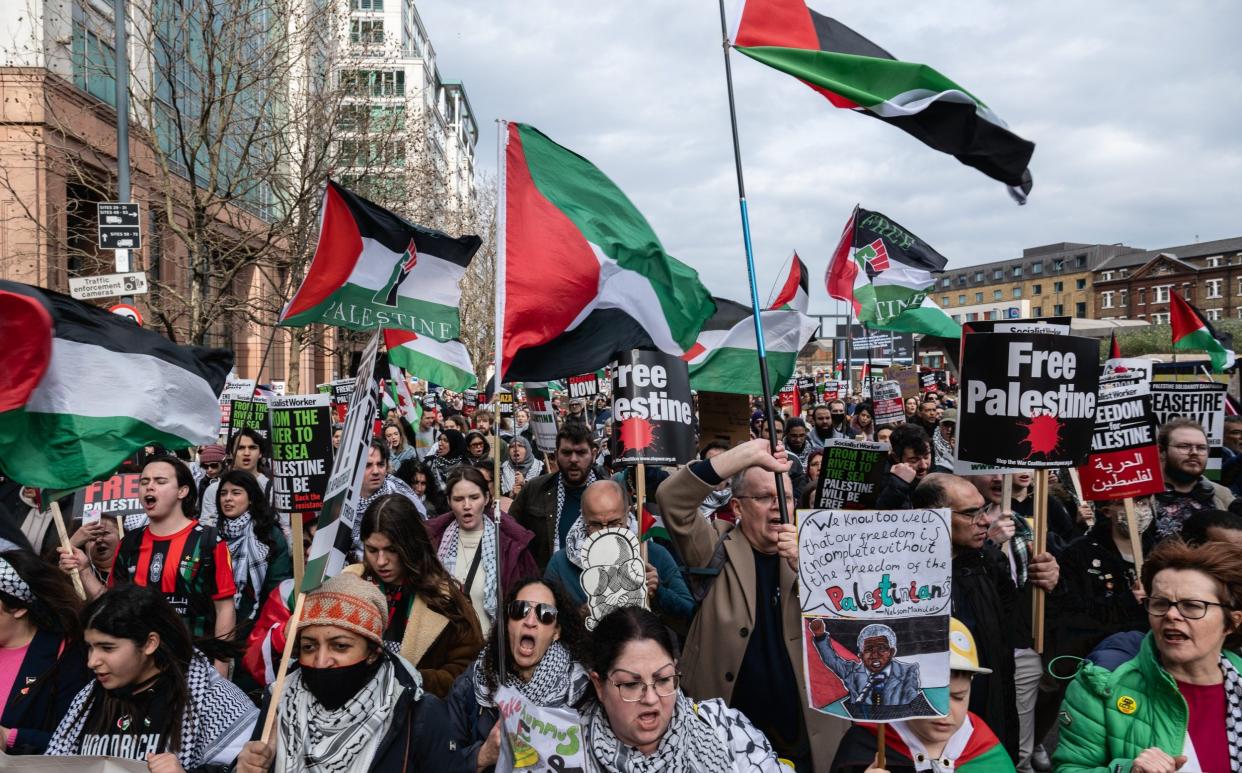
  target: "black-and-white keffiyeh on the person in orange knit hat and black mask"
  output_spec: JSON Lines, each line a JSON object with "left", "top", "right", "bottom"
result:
{"left": 273, "top": 660, "right": 402, "bottom": 773}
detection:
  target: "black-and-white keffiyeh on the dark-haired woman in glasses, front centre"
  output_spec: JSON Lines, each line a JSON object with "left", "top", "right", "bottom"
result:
{"left": 582, "top": 692, "right": 755, "bottom": 773}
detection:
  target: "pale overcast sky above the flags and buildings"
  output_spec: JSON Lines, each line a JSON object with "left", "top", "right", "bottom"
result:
{"left": 417, "top": 0, "right": 1242, "bottom": 313}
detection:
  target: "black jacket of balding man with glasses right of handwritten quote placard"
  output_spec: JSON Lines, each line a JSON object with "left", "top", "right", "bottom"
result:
{"left": 953, "top": 546, "right": 1031, "bottom": 753}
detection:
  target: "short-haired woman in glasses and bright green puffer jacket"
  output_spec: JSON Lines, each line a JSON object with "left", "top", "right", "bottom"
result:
{"left": 1053, "top": 541, "right": 1242, "bottom": 773}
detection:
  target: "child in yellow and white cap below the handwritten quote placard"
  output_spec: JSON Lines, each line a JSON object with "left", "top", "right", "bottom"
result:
{"left": 831, "top": 619, "right": 1013, "bottom": 773}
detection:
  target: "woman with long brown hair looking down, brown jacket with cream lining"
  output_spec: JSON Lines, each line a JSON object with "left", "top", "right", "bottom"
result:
{"left": 355, "top": 495, "right": 483, "bottom": 697}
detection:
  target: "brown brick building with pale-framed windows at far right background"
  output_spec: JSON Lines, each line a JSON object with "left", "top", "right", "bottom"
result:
{"left": 1093, "top": 236, "right": 1242, "bottom": 324}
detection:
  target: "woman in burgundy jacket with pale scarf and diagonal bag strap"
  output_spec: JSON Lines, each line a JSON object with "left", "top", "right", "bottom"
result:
{"left": 427, "top": 467, "right": 539, "bottom": 639}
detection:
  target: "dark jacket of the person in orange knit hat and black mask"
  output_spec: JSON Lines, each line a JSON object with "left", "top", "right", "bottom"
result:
{"left": 251, "top": 650, "right": 453, "bottom": 773}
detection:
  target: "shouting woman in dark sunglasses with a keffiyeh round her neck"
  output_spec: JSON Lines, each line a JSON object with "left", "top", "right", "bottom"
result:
{"left": 446, "top": 578, "right": 591, "bottom": 771}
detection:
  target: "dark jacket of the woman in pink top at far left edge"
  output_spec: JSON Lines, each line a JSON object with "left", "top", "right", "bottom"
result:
{"left": 0, "top": 631, "right": 93, "bottom": 754}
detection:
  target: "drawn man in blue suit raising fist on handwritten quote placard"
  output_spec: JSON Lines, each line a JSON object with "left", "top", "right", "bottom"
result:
{"left": 810, "top": 620, "right": 939, "bottom": 720}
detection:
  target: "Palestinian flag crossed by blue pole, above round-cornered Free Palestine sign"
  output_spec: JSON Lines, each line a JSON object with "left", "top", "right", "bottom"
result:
{"left": 682, "top": 255, "right": 818, "bottom": 395}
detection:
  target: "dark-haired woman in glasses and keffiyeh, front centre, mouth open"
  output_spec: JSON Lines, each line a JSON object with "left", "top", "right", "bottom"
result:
{"left": 582, "top": 606, "right": 781, "bottom": 773}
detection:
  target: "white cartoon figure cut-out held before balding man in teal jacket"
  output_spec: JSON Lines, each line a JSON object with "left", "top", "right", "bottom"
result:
{"left": 580, "top": 528, "right": 647, "bottom": 630}
